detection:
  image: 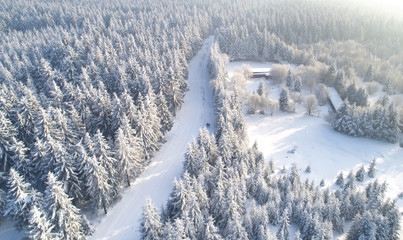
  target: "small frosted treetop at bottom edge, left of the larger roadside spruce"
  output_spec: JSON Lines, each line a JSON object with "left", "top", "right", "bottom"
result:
{"left": 28, "top": 206, "right": 59, "bottom": 240}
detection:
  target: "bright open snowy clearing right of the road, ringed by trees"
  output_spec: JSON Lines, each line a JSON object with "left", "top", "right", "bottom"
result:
{"left": 227, "top": 62, "right": 403, "bottom": 236}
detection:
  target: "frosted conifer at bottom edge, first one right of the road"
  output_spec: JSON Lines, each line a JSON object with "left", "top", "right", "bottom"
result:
{"left": 140, "top": 199, "right": 162, "bottom": 240}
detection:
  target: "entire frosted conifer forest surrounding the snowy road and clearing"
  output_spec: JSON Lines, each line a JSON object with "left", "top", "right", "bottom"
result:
{"left": 0, "top": 0, "right": 403, "bottom": 240}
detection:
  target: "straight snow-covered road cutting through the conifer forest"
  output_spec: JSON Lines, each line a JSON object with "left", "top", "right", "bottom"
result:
{"left": 90, "top": 36, "right": 215, "bottom": 240}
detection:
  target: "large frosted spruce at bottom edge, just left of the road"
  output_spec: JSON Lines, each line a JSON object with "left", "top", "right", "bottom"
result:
{"left": 43, "top": 172, "right": 84, "bottom": 239}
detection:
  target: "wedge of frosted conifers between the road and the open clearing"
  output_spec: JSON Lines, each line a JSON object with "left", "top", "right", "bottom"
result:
{"left": 140, "top": 41, "right": 400, "bottom": 239}
